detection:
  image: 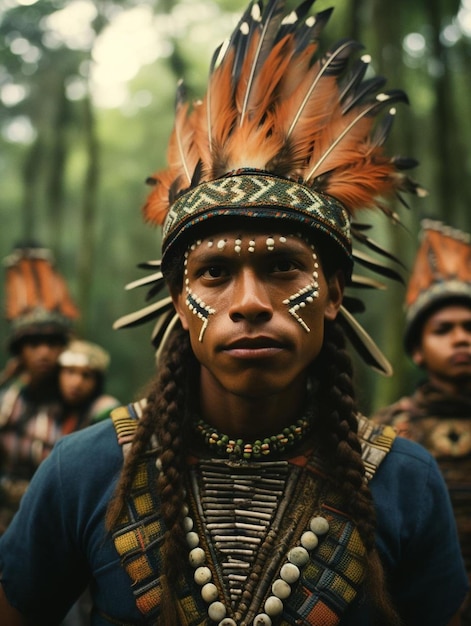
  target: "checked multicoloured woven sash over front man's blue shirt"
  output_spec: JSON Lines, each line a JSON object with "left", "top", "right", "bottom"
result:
{"left": 111, "top": 404, "right": 394, "bottom": 626}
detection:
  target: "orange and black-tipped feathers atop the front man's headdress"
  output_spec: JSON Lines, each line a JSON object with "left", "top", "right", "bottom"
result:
{"left": 143, "top": 0, "right": 421, "bottom": 224}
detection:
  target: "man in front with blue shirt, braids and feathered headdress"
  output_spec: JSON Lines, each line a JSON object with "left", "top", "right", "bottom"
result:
{"left": 0, "top": 2, "right": 467, "bottom": 626}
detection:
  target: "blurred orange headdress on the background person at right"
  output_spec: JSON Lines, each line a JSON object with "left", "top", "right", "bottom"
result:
{"left": 405, "top": 220, "right": 471, "bottom": 352}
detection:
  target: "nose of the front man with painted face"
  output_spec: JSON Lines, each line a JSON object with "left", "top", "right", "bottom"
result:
{"left": 229, "top": 268, "right": 273, "bottom": 322}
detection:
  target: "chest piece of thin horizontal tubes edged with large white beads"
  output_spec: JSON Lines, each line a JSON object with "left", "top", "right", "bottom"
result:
{"left": 184, "top": 459, "right": 329, "bottom": 626}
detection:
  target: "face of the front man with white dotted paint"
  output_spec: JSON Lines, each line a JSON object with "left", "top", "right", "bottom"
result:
{"left": 174, "top": 230, "right": 342, "bottom": 398}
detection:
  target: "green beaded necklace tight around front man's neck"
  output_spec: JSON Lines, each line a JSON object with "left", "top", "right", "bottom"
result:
{"left": 194, "top": 415, "right": 311, "bottom": 461}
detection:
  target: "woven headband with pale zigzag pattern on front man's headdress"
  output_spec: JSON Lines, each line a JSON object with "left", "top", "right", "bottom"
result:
{"left": 162, "top": 170, "right": 351, "bottom": 265}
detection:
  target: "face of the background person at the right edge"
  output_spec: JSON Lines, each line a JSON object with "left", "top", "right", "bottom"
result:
{"left": 412, "top": 304, "right": 471, "bottom": 387}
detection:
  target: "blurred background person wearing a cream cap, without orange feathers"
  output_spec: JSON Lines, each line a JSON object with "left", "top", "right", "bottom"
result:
{"left": 59, "top": 339, "right": 120, "bottom": 428}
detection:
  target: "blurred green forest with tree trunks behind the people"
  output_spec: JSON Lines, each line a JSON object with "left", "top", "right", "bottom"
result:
{"left": 0, "top": 0, "right": 471, "bottom": 414}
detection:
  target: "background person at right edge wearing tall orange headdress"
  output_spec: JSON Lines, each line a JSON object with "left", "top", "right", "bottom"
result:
{"left": 373, "top": 220, "right": 471, "bottom": 626}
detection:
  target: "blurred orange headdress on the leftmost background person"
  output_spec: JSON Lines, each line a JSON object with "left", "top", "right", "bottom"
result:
{"left": 3, "top": 244, "right": 79, "bottom": 352}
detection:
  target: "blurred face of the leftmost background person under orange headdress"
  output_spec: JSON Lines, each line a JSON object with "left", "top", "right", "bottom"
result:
{"left": 20, "top": 335, "right": 65, "bottom": 383}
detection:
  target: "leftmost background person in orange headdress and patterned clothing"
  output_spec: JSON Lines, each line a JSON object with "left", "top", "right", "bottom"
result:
{"left": 0, "top": 244, "right": 78, "bottom": 534}
